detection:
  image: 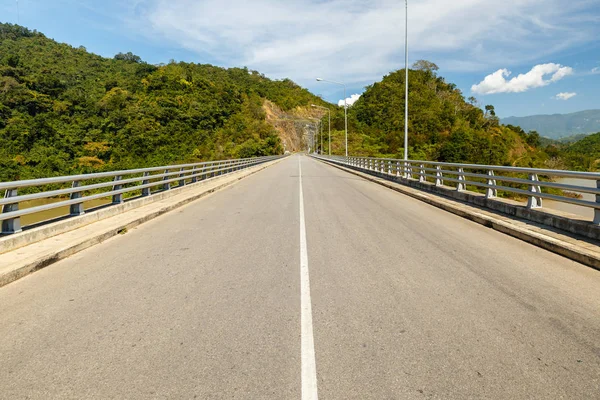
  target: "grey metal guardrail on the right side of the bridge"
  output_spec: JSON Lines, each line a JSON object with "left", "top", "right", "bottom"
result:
{"left": 313, "top": 155, "right": 600, "bottom": 225}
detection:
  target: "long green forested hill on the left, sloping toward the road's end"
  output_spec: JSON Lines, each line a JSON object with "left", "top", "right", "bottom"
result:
{"left": 0, "top": 24, "right": 327, "bottom": 181}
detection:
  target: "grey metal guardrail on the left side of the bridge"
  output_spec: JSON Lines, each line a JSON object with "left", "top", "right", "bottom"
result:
{"left": 0, "top": 156, "right": 283, "bottom": 234}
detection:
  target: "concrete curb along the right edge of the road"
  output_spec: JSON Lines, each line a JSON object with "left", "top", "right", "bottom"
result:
{"left": 317, "top": 159, "right": 600, "bottom": 271}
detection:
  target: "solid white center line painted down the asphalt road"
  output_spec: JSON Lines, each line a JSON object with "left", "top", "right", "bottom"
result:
{"left": 298, "top": 158, "right": 319, "bottom": 400}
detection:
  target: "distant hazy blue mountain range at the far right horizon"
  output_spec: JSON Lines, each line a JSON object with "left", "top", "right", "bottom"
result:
{"left": 501, "top": 110, "right": 600, "bottom": 139}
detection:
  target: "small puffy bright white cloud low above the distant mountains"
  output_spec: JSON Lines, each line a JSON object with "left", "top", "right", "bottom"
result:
{"left": 471, "top": 63, "right": 573, "bottom": 94}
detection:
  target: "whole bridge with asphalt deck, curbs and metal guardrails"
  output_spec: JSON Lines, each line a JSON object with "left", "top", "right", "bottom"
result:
{"left": 0, "top": 154, "right": 600, "bottom": 399}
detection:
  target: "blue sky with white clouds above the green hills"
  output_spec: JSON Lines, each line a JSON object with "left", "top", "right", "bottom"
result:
{"left": 0, "top": 0, "right": 600, "bottom": 117}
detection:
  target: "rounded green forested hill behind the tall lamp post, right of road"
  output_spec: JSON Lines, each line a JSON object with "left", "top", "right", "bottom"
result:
{"left": 336, "top": 60, "right": 548, "bottom": 166}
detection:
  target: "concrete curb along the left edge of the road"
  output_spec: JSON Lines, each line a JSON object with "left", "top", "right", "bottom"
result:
{"left": 0, "top": 158, "right": 284, "bottom": 287}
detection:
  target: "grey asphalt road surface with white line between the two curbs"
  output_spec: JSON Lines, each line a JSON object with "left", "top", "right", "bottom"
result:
{"left": 0, "top": 155, "right": 600, "bottom": 399}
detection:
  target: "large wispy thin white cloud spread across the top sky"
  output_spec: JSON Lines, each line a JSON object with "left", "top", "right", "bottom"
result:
{"left": 136, "top": 0, "right": 600, "bottom": 88}
